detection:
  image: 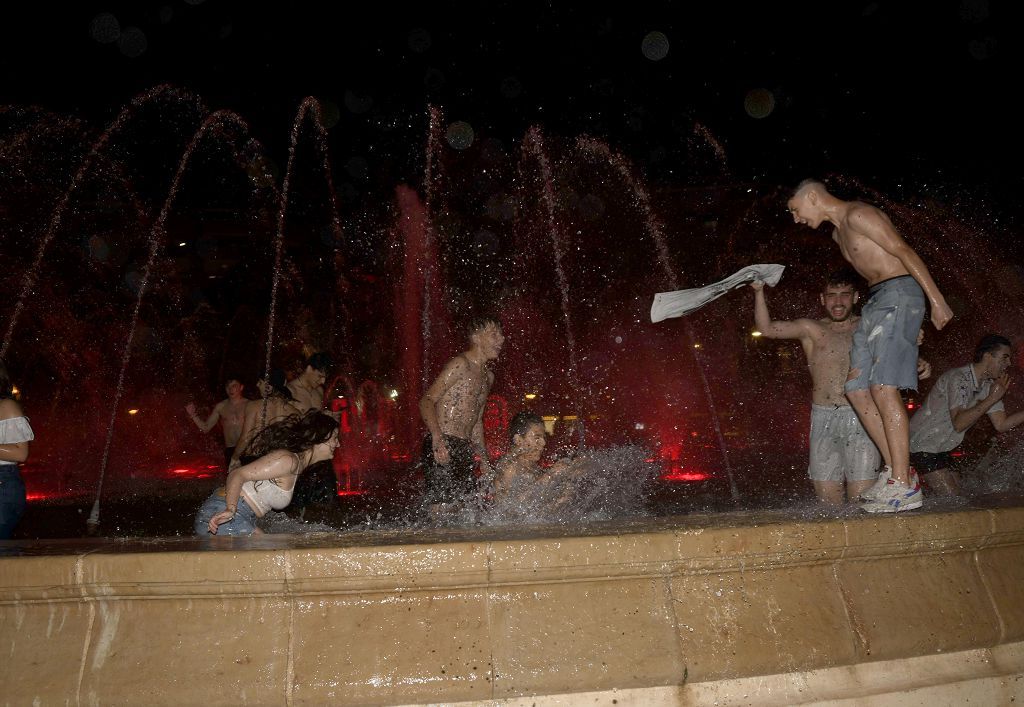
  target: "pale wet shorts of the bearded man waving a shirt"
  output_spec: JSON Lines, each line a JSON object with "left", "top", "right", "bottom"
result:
{"left": 807, "top": 405, "right": 881, "bottom": 483}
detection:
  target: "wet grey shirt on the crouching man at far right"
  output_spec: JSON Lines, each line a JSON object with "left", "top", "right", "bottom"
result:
{"left": 910, "top": 364, "right": 1004, "bottom": 454}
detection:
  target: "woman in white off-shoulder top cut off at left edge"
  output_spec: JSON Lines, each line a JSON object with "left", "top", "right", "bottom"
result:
{"left": 0, "top": 364, "right": 35, "bottom": 540}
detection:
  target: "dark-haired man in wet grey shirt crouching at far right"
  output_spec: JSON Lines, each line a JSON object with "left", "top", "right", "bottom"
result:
{"left": 910, "top": 334, "right": 1024, "bottom": 495}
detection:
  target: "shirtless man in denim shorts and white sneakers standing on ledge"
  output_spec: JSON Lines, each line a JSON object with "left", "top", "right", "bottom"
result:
{"left": 786, "top": 179, "right": 953, "bottom": 512}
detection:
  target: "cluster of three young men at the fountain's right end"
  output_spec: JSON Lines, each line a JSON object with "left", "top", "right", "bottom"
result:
{"left": 770, "top": 179, "right": 1024, "bottom": 513}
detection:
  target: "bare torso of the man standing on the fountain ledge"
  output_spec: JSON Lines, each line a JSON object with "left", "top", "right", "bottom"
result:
{"left": 833, "top": 202, "right": 909, "bottom": 285}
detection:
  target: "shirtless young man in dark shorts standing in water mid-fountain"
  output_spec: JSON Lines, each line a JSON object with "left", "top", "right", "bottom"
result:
{"left": 420, "top": 317, "right": 505, "bottom": 522}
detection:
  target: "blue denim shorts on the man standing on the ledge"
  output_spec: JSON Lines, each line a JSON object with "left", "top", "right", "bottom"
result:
{"left": 846, "top": 275, "right": 925, "bottom": 392}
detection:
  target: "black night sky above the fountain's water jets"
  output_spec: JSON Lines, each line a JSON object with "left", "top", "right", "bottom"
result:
{"left": 0, "top": 0, "right": 1022, "bottom": 216}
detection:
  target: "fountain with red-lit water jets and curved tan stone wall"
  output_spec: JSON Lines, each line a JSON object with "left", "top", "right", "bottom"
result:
{"left": 0, "top": 90, "right": 1024, "bottom": 705}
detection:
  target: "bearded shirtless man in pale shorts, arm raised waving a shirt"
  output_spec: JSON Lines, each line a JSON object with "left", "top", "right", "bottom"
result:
{"left": 751, "top": 269, "right": 880, "bottom": 505}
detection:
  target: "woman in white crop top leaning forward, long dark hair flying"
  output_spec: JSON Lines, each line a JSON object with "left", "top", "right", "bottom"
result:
{"left": 194, "top": 410, "right": 339, "bottom": 536}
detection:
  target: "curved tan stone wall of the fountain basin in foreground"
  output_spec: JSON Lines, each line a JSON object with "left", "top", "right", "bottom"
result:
{"left": 0, "top": 498, "right": 1024, "bottom": 705}
